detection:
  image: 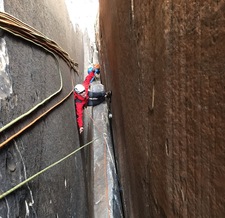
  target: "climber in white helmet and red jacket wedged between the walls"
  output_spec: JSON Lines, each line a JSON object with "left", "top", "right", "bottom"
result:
{"left": 74, "top": 64, "right": 112, "bottom": 134}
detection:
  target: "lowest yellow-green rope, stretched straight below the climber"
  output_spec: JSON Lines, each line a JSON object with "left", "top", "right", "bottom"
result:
{"left": 0, "top": 138, "right": 99, "bottom": 199}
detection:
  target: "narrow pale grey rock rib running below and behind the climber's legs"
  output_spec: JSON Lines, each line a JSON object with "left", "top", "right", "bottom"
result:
{"left": 89, "top": 82, "right": 123, "bottom": 218}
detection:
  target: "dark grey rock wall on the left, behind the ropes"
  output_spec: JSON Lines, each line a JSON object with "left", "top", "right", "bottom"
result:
{"left": 0, "top": 0, "right": 88, "bottom": 217}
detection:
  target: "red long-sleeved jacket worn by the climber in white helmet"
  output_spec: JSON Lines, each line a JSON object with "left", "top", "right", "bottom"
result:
{"left": 73, "top": 71, "right": 95, "bottom": 128}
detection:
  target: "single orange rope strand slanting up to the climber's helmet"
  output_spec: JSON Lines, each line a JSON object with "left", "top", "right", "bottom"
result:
{"left": 0, "top": 91, "right": 73, "bottom": 148}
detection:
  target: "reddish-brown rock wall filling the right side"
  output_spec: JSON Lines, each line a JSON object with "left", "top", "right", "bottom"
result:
{"left": 99, "top": 0, "right": 225, "bottom": 217}
